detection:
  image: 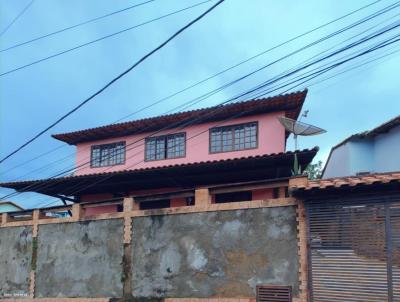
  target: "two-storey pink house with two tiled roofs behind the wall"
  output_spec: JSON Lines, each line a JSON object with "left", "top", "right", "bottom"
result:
{"left": 1, "top": 90, "right": 317, "bottom": 215}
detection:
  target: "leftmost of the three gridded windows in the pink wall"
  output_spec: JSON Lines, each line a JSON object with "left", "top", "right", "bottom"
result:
{"left": 90, "top": 142, "right": 125, "bottom": 168}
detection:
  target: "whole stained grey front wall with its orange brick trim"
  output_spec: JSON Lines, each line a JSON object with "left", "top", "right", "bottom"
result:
{"left": 0, "top": 192, "right": 301, "bottom": 302}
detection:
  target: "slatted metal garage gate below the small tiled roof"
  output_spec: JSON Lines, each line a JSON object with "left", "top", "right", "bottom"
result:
{"left": 307, "top": 195, "right": 400, "bottom": 302}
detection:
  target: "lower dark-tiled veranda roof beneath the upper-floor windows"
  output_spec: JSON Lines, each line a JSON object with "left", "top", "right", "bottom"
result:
{"left": 0, "top": 147, "right": 318, "bottom": 194}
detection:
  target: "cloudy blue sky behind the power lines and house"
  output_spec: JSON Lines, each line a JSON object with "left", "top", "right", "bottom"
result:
{"left": 0, "top": 0, "right": 400, "bottom": 207}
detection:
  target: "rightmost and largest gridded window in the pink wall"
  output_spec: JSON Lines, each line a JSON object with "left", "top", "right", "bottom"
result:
{"left": 210, "top": 122, "right": 258, "bottom": 153}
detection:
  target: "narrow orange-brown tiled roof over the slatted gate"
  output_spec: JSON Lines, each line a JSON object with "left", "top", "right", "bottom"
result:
{"left": 291, "top": 172, "right": 400, "bottom": 191}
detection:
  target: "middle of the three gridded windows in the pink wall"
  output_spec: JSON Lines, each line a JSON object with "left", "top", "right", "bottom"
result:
{"left": 145, "top": 133, "right": 186, "bottom": 161}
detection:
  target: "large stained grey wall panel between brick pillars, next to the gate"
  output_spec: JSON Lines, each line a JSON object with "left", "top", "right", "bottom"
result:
{"left": 132, "top": 207, "right": 298, "bottom": 298}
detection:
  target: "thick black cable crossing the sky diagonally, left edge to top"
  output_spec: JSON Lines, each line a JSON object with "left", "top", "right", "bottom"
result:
{"left": 0, "top": 0, "right": 224, "bottom": 163}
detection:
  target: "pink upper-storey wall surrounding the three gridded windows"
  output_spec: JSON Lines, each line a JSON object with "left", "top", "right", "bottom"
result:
{"left": 76, "top": 112, "right": 285, "bottom": 175}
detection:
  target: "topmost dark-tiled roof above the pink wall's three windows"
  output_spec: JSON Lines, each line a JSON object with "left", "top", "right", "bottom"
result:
{"left": 52, "top": 90, "right": 307, "bottom": 145}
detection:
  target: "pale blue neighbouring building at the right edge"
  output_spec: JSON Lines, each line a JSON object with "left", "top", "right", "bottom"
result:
{"left": 322, "top": 116, "right": 400, "bottom": 178}
